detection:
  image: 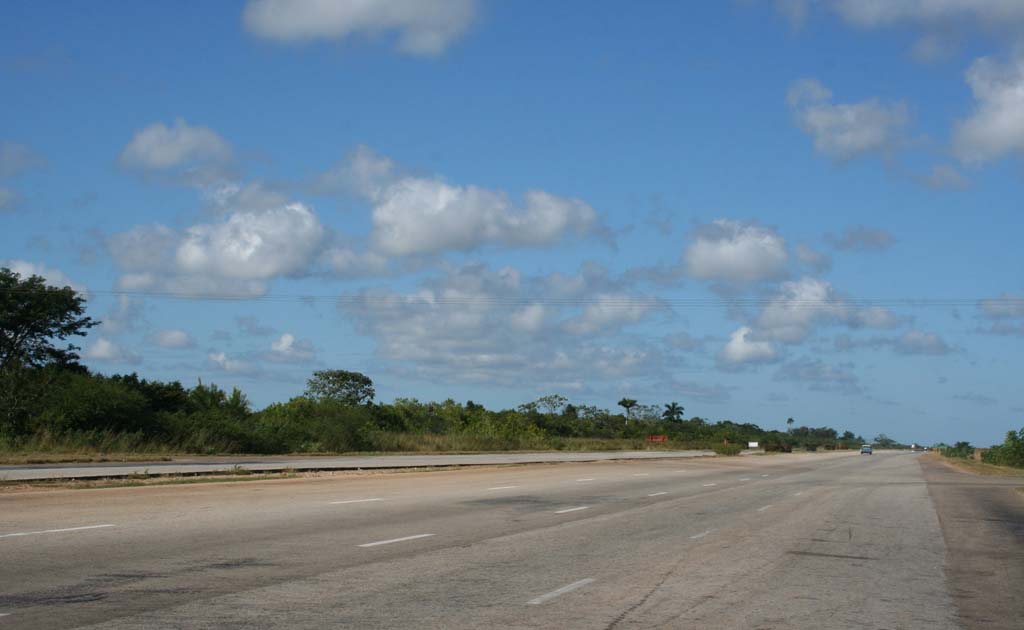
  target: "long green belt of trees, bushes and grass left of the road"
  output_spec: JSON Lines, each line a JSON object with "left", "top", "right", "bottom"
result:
{"left": 0, "top": 268, "right": 884, "bottom": 462}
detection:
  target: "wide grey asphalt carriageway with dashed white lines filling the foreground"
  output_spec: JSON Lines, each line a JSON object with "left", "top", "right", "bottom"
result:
{"left": 0, "top": 453, "right": 1024, "bottom": 630}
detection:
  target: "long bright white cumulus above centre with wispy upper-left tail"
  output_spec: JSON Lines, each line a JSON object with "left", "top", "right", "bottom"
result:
{"left": 317, "top": 148, "right": 607, "bottom": 257}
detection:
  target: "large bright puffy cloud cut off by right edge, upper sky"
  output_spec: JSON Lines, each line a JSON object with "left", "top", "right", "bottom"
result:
{"left": 953, "top": 54, "right": 1024, "bottom": 163}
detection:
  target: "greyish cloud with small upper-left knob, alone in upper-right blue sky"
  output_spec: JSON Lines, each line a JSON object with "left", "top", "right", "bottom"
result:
{"left": 786, "top": 79, "right": 908, "bottom": 162}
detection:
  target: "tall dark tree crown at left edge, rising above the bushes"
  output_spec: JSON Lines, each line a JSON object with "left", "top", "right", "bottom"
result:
{"left": 0, "top": 267, "right": 99, "bottom": 375}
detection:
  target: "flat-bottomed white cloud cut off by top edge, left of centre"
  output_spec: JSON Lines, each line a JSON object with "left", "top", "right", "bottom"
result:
{"left": 242, "top": 0, "right": 476, "bottom": 54}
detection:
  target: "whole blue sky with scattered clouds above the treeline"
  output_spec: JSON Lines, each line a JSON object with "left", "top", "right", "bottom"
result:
{"left": 0, "top": 0, "right": 1024, "bottom": 446}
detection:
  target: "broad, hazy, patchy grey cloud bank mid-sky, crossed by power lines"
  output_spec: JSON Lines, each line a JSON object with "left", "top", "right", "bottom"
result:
{"left": 339, "top": 264, "right": 668, "bottom": 386}
